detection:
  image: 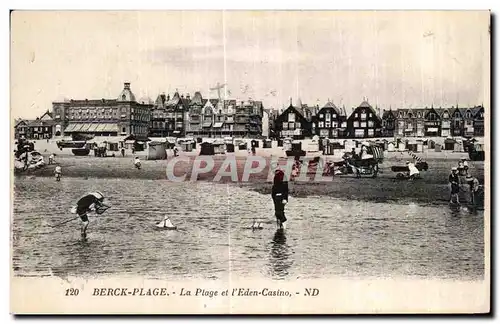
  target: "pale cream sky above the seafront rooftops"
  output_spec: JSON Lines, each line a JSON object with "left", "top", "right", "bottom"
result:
{"left": 10, "top": 11, "right": 490, "bottom": 118}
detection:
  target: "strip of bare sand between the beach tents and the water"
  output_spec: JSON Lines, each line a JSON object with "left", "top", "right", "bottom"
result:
{"left": 18, "top": 155, "right": 484, "bottom": 204}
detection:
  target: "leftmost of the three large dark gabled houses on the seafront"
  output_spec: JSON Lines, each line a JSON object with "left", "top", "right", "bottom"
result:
{"left": 275, "top": 100, "right": 312, "bottom": 139}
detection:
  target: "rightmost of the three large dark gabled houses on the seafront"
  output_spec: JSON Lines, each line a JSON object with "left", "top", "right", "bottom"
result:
{"left": 347, "top": 101, "right": 382, "bottom": 138}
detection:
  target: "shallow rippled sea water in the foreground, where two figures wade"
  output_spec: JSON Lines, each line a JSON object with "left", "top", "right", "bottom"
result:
{"left": 13, "top": 178, "right": 484, "bottom": 279}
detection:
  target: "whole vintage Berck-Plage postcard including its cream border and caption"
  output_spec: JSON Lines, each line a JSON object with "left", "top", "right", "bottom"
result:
{"left": 10, "top": 10, "right": 492, "bottom": 314}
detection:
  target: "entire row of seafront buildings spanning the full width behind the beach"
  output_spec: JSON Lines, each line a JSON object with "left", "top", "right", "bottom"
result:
{"left": 15, "top": 83, "right": 484, "bottom": 139}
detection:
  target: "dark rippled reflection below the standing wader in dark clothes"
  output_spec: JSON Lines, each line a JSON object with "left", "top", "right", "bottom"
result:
{"left": 269, "top": 229, "right": 293, "bottom": 278}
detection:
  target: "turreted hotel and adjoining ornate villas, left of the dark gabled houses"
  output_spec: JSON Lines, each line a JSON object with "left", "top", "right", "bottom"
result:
{"left": 51, "top": 83, "right": 264, "bottom": 137}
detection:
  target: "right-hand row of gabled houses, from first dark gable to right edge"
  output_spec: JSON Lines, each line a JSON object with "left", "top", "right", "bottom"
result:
{"left": 272, "top": 101, "right": 484, "bottom": 138}
